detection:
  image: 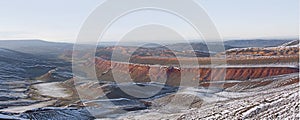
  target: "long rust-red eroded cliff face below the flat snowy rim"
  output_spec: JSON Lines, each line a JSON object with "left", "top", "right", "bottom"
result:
{"left": 96, "top": 59, "right": 299, "bottom": 86}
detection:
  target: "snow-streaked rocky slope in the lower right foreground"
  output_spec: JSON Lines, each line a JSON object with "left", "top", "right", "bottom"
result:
{"left": 118, "top": 74, "right": 300, "bottom": 120}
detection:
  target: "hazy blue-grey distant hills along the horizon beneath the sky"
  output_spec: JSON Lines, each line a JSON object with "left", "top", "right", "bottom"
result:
{"left": 0, "top": 39, "right": 292, "bottom": 57}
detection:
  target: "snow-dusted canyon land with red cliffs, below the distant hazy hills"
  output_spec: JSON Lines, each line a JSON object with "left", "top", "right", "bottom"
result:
{"left": 0, "top": 41, "right": 299, "bottom": 119}
